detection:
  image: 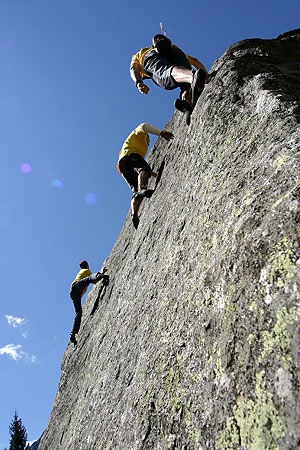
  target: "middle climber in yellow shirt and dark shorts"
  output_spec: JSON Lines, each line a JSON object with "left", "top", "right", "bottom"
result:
{"left": 117, "top": 123, "right": 173, "bottom": 229}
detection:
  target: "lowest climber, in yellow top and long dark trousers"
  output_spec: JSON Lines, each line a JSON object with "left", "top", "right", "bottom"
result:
{"left": 70, "top": 261, "right": 109, "bottom": 345}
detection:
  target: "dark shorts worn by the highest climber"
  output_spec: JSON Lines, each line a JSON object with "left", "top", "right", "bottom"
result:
{"left": 143, "top": 47, "right": 192, "bottom": 90}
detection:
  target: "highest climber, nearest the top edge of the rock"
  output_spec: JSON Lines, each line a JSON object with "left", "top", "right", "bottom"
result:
{"left": 130, "top": 34, "right": 208, "bottom": 123}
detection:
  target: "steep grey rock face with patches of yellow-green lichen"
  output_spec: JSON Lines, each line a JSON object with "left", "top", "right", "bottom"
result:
{"left": 39, "top": 30, "right": 300, "bottom": 450}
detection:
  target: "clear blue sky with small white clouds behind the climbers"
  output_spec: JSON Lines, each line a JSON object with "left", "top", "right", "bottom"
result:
{"left": 0, "top": 0, "right": 300, "bottom": 450}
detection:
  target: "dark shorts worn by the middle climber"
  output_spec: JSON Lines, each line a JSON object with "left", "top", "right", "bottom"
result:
{"left": 119, "top": 153, "right": 152, "bottom": 193}
